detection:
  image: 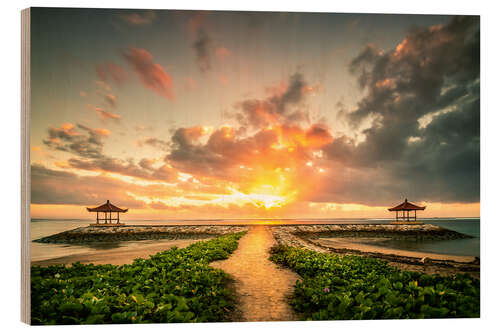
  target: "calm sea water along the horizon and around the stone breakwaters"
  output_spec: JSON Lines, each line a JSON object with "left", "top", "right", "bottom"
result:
{"left": 31, "top": 218, "right": 480, "bottom": 261}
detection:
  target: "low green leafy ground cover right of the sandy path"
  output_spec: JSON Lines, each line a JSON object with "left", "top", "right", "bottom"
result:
{"left": 271, "top": 245, "right": 480, "bottom": 320}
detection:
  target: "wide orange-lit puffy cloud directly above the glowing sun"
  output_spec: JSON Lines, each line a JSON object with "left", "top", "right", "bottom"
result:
{"left": 165, "top": 124, "right": 332, "bottom": 186}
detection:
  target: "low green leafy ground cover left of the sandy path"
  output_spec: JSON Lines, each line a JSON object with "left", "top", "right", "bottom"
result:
{"left": 31, "top": 233, "right": 244, "bottom": 325}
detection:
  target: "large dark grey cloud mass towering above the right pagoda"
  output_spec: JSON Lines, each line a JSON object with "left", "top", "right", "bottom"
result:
{"left": 324, "top": 17, "right": 480, "bottom": 204}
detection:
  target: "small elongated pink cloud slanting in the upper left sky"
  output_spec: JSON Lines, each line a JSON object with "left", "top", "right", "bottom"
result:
{"left": 123, "top": 48, "right": 175, "bottom": 101}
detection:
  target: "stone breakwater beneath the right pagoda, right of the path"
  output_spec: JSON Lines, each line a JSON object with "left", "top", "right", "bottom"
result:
{"left": 273, "top": 224, "right": 471, "bottom": 240}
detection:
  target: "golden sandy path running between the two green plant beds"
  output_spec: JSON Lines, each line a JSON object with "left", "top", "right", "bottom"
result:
{"left": 211, "top": 226, "right": 300, "bottom": 321}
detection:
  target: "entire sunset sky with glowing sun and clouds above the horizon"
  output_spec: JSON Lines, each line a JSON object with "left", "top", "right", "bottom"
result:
{"left": 30, "top": 8, "right": 480, "bottom": 219}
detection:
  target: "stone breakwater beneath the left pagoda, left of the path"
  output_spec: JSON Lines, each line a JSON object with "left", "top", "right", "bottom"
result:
{"left": 34, "top": 225, "right": 248, "bottom": 244}
